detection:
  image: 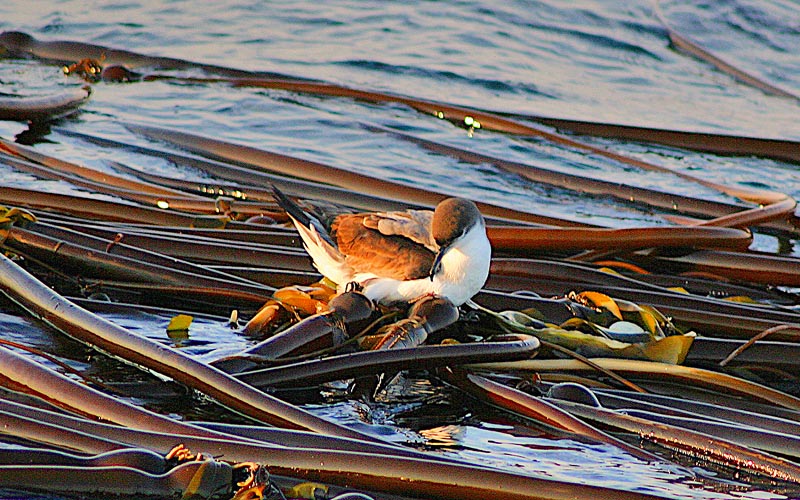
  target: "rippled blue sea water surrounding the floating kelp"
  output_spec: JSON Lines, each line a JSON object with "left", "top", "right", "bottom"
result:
{"left": 0, "top": 0, "right": 800, "bottom": 498}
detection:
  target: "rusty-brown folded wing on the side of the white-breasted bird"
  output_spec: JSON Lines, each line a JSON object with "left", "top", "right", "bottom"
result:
{"left": 331, "top": 214, "right": 434, "bottom": 280}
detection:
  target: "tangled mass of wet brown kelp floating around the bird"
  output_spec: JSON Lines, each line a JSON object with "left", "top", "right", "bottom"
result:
{"left": 0, "top": 30, "right": 800, "bottom": 499}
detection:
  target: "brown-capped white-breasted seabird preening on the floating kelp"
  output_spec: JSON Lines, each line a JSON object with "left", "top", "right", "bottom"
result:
{"left": 273, "top": 186, "right": 492, "bottom": 306}
